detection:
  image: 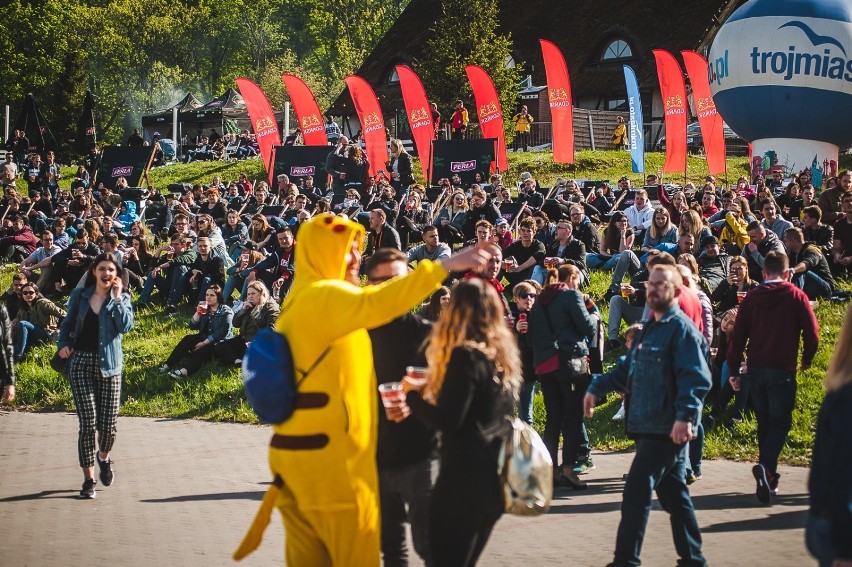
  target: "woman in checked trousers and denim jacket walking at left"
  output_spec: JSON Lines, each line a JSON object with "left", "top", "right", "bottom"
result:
{"left": 57, "top": 253, "right": 133, "bottom": 498}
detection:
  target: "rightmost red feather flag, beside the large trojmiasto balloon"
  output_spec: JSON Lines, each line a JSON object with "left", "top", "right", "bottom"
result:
{"left": 680, "top": 51, "right": 727, "bottom": 175}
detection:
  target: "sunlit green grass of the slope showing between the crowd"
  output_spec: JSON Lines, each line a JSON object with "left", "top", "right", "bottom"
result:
{"left": 28, "top": 152, "right": 852, "bottom": 465}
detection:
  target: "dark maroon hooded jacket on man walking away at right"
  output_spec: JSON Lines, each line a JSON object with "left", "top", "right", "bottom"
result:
{"left": 727, "top": 282, "right": 819, "bottom": 372}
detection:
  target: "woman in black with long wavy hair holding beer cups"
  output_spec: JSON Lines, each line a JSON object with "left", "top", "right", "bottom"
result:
{"left": 403, "top": 278, "right": 521, "bottom": 565}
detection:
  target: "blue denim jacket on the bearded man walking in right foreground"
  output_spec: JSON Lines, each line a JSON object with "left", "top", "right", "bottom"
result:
{"left": 588, "top": 305, "right": 711, "bottom": 436}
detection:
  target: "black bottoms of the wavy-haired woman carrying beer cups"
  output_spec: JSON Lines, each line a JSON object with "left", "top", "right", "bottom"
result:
{"left": 429, "top": 463, "right": 504, "bottom": 567}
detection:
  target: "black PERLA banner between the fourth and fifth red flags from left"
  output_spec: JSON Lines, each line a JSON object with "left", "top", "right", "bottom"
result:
{"left": 432, "top": 138, "right": 497, "bottom": 185}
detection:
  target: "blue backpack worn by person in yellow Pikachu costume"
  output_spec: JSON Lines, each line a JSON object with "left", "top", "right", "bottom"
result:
{"left": 243, "top": 329, "right": 331, "bottom": 424}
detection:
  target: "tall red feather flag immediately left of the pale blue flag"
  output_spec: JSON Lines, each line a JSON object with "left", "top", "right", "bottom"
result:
{"left": 538, "top": 39, "right": 574, "bottom": 163}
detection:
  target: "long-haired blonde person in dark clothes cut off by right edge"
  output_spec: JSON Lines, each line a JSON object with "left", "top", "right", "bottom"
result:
{"left": 805, "top": 307, "right": 852, "bottom": 567}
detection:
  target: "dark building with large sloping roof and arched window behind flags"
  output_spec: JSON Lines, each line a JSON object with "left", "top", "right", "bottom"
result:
{"left": 328, "top": 0, "right": 745, "bottom": 147}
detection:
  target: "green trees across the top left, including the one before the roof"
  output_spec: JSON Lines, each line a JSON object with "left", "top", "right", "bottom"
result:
{"left": 0, "top": 0, "right": 520, "bottom": 158}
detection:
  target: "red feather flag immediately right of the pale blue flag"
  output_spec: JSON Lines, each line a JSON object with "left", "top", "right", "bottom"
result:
{"left": 654, "top": 49, "right": 688, "bottom": 172}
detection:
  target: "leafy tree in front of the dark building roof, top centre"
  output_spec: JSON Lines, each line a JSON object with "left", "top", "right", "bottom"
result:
{"left": 415, "top": 0, "right": 521, "bottom": 141}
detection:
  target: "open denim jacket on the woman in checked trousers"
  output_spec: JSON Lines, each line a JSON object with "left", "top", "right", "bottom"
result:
{"left": 56, "top": 286, "right": 133, "bottom": 376}
